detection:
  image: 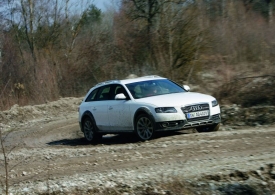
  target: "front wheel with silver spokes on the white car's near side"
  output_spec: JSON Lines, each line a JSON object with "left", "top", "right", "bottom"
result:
{"left": 135, "top": 114, "right": 155, "bottom": 141}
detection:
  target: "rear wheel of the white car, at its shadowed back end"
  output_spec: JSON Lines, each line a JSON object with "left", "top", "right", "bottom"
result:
{"left": 83, "top": 117, "right": 102, "bottom": 142}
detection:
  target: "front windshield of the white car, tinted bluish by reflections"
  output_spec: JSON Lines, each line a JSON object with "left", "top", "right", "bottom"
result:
{"left": 126, "top": 79, "right": 186, "bottom": 99}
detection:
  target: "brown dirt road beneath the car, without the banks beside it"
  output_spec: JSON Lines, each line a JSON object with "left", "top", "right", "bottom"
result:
{"left": 0, "top": 109, "right": 275, "bottom": 194}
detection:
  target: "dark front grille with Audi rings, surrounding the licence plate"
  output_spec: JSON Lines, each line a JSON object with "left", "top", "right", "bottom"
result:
{"left": 181, "top": 103, "right": 210, "bottom": 122}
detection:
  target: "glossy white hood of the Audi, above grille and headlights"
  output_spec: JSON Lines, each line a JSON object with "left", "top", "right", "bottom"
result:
{"left": 136, "top": 92, "right": 215, "bottom": 107}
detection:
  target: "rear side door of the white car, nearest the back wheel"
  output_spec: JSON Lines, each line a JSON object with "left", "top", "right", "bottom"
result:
{"left": 90, "top": 85, "right": 111, "bottom": 131}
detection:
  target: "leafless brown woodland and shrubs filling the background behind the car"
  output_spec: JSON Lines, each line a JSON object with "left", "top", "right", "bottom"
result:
{"left": 0, "top": 0, "right": 275, "bottom": 110}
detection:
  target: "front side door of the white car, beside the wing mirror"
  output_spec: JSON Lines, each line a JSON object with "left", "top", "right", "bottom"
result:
{"left": 108, "top": 84, "right": 132, "bottom": 131}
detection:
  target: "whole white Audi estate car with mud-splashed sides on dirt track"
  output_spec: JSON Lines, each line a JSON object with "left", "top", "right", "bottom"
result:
{"left": 78, "top": 75, "right": 221, "bottom": 142}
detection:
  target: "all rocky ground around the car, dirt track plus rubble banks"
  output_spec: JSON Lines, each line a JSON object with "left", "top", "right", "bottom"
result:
{"left": 0, "top": 98, "right": 275, "bottom": 195}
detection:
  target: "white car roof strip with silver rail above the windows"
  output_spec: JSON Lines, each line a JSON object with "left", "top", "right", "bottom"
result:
{"left": 93, "top": 75, "right": 166, "bottom": 88}
